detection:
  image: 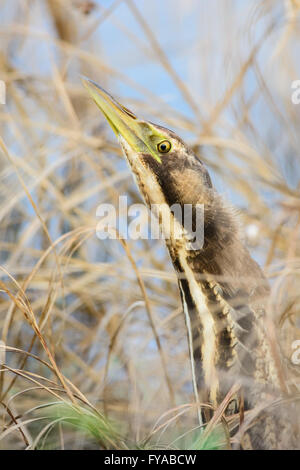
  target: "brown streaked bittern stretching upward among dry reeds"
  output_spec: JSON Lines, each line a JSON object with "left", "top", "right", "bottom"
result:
{"left": 84, "top": 79, "right": 291, "bottom": 449}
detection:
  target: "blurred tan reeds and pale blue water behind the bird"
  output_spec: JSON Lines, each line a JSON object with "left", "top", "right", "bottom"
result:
{"left": 0, "top": 0, "right": 300, "bottom": 449}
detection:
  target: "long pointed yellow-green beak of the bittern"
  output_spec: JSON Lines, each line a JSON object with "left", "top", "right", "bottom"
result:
{"left": 82, "top": 77, "right": 149, "bottom": 153}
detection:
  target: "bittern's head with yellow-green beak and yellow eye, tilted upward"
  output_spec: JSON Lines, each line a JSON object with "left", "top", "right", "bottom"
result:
{"left": 83, "top": 79, "right": 211, "bottom": 211}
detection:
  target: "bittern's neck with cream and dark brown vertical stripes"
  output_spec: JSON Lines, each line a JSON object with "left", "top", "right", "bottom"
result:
{"left": 167, "top": 196, "right": 267, "bottom": 405}
